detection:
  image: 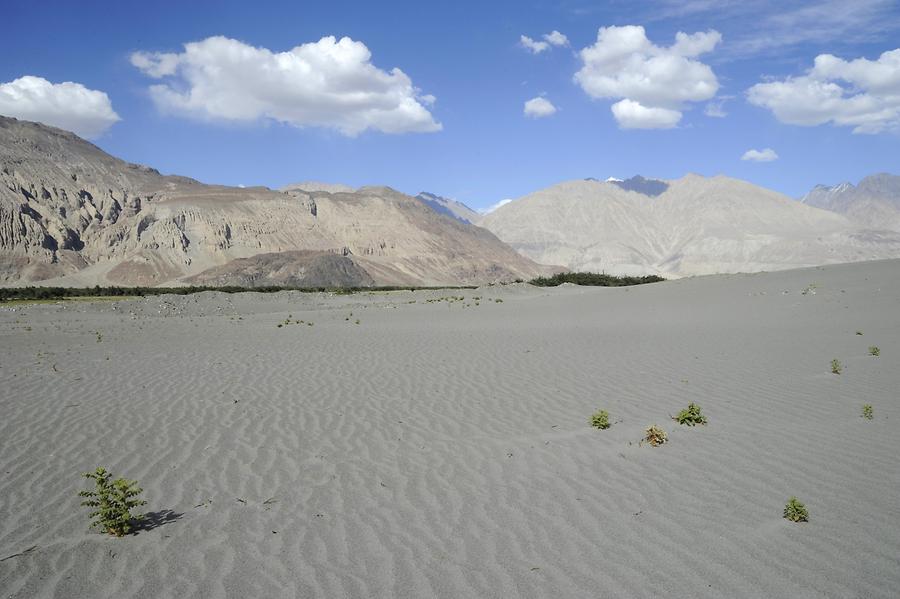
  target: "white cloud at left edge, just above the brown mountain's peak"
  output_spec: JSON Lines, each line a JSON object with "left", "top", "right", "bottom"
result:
{"left": 0, "top": 75, "right": 121, "bottom": 138}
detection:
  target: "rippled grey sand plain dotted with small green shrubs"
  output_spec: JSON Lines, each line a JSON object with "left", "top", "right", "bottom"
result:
{"left": 0, "top": 261, "right": 900, "bottom": 598}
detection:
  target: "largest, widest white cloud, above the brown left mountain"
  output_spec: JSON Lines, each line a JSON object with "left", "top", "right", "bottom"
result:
{"left": 131, "top": 36, "right": 441, "bottom": 136}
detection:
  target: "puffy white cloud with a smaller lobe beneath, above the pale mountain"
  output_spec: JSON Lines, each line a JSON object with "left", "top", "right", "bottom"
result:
{"left": 575, "top": 25, "right": 722, "bottom": 129}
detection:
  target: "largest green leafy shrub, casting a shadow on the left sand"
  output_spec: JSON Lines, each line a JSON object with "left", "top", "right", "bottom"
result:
{"left": 78, "top": 466, "right": 147, "bottom": 537}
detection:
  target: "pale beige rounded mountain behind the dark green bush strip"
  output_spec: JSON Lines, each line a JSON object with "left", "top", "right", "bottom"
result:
{"left": 479, "top": 175, "right": 900, "bottom": 277}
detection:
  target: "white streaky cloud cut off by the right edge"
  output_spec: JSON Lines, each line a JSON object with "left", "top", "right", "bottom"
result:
{"left": 747, "top": 48, "right": 900, "bottom": 133}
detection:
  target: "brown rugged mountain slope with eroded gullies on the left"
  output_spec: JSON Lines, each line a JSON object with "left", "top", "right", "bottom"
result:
{"left": 0, "top": 117, "right": 547, "bottom": 286}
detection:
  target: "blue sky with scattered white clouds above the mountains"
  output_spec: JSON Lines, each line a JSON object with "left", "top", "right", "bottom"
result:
{"left": 0, "top": 0, "right": 900, "bottom": 208}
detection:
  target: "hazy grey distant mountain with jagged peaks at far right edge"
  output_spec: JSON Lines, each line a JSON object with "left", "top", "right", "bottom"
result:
{"left": 800, "top": 173, "right": 900, "bottom": 231}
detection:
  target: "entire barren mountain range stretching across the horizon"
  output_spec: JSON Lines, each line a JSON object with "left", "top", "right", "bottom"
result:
{"left": 0, "top": 117, "right": 900, "bottom": 287}
